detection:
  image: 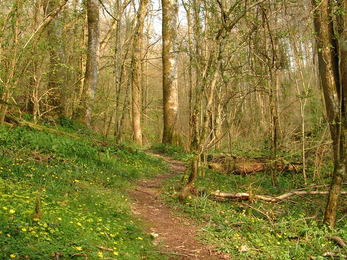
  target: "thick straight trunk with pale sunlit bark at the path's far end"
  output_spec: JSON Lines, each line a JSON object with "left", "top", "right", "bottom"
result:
{"left": 162, "top": 0, "right": 178, "bottom": 144}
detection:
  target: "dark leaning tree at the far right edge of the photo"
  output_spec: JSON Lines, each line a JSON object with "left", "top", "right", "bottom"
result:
{"left": 312, "top": 0, "right": 347, "bottom": 228}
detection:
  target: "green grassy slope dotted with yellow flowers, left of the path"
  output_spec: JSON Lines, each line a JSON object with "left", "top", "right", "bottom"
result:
{"left": 0, "top": 127, "right": 169, "bottom": 260}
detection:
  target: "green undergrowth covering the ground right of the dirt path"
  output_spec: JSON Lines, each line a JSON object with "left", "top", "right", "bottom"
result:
{"left": 163, "top": 161, "right": 347, "bottom": 259}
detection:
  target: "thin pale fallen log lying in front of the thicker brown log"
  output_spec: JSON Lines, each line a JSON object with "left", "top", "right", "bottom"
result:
{"left": 211, "top": 190, "right": 347, "bottom": 202}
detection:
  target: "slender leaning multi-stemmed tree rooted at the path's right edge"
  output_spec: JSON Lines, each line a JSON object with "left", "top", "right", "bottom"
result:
{"left": 181, "top": 1, "right": 266, "bottom": 198}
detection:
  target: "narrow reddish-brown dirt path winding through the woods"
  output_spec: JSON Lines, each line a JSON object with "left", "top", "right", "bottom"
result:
{"left": 130, "top": 155, "right": 226, "bottom": 260}
